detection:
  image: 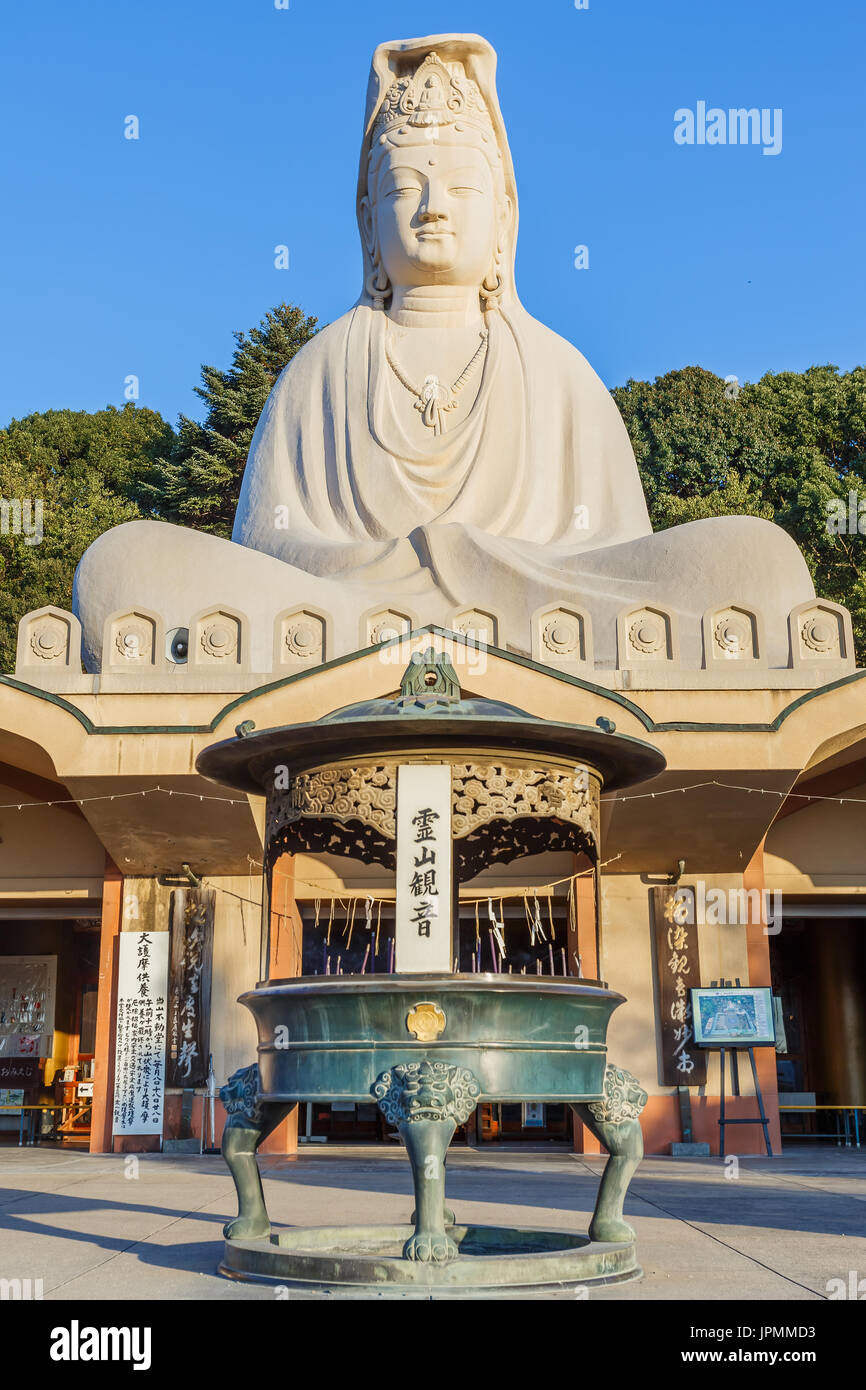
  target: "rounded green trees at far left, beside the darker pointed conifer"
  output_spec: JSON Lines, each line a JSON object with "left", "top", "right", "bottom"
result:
{"left": 0, "top": 403, "right": 174, "bottom": 671}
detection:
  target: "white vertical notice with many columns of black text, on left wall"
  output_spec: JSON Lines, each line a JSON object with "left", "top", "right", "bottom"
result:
{"left": 113, "top": 931, "right": 170, "bottom": 1136}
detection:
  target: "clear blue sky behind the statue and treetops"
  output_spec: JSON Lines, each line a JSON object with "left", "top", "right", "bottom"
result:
{"left": 0, "top": 0, "right": 866, "bottom": 424}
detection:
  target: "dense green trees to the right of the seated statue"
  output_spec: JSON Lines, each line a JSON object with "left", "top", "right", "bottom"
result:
{"left": 613, "top": 366, "right": 866, "bottom": 662}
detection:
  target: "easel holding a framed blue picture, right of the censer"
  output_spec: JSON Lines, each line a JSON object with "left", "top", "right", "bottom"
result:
{"left": 691, "top": 980, "right": 776, "bottom": 1158}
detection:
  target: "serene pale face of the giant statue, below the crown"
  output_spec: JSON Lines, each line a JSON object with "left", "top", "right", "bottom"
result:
{"left": 364, "top": 142, "right": 502, "bottom": 288}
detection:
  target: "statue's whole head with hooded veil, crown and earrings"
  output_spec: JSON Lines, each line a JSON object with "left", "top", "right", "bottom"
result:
{"left": 359, "top": 35, "right": 517, "bottom": 309}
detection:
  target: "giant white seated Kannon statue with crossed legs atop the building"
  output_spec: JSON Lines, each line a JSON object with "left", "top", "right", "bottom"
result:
{"left": 75, "top": 35, "right": 815, "bottom": 669}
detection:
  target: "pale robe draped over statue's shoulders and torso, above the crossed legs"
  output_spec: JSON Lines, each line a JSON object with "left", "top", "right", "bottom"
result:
{"left": 234, "top": 304, "right": 651, "bottom": 603}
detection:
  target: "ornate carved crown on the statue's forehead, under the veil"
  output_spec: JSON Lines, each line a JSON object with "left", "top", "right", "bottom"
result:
{"left": 373, "top": 53, "right": 493, "bottom": 142}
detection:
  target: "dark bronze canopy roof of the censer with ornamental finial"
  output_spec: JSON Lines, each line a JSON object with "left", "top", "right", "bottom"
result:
{"left": 196, "top": 649, "right": 666, "bottom": 795}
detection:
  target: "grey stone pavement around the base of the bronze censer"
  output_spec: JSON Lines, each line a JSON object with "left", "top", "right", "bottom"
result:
{"left": 0, "top": 1145, "right": 866, "bottom": 1301}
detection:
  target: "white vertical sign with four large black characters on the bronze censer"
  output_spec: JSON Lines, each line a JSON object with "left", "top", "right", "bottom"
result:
{"left": 395, "top": 763, "right": 452, "bottom": 974}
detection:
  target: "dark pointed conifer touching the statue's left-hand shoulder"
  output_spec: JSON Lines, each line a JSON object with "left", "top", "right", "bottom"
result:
{"left": 142, "top": 304, "right": 317, "bottom": 537}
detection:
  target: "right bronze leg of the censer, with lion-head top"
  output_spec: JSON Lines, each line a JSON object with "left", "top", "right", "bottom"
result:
{"left": 571, "top": 1066, "right": 646, "bottom": 1243}
